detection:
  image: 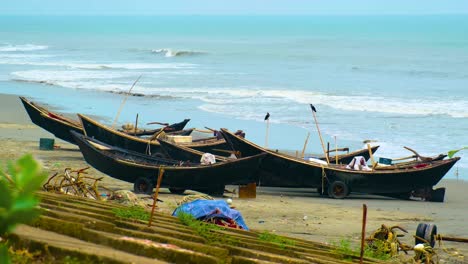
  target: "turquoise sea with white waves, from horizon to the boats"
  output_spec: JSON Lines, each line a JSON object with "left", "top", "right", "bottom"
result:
{"left": 0, "top": 15, "right": 468, "bottom": 178}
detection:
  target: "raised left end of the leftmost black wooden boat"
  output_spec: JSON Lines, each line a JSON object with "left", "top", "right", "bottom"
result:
{"left": 20, "top": 97, "right": 83, "bottom": 144}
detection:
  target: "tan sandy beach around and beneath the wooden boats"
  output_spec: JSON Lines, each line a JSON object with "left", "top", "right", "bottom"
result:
{"left": 0, "top": 92, "right": 468, "bottom": 261}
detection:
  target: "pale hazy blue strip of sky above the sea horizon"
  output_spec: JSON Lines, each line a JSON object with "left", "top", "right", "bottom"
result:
{"left": 0, "top": 0, "right": 468, "bottom": 15}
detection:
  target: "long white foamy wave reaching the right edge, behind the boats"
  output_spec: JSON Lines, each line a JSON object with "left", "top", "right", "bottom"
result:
{"left": 143, "top": 88, "right": 468, "bottom": 118}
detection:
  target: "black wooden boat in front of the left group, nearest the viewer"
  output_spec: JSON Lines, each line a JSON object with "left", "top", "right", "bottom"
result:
{"left": 71, "top": 132, "right": 266, "bottom": 195}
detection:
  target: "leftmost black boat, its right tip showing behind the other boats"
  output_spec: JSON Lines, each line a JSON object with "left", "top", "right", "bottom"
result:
{"left": 20, "top": 96, "right": 193, "bottom": 144}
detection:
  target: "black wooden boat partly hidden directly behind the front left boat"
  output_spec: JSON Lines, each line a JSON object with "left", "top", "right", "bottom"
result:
{"left": 78, "top": 114, "right": 234, "bottom": 157}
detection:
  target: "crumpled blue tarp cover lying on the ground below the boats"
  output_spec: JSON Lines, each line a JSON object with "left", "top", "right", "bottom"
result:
{"left": 172, "top": 200, "right": 249, "bottom": 230}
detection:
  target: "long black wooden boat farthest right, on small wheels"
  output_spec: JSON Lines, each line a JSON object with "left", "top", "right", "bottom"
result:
{"left": 221, "top": 129, "right": 460, "bottom": 201}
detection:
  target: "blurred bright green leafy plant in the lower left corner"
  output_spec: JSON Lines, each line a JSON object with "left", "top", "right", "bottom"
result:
{"left": 0, "top": 154, "right": 47, "bottom": 263}
